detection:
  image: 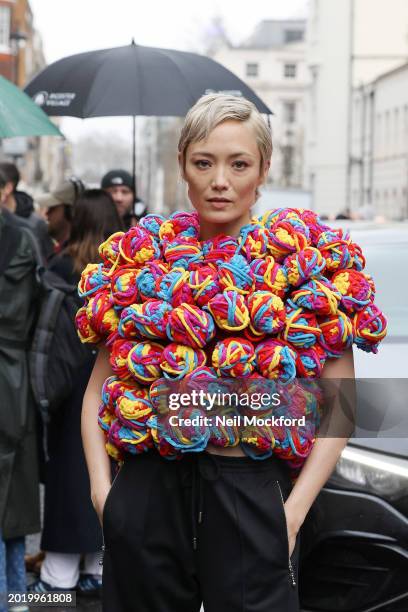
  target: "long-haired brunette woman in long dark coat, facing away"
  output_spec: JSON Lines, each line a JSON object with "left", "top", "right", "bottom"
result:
{"left": 29, "top": 189, "right": 123, "bottom": 595}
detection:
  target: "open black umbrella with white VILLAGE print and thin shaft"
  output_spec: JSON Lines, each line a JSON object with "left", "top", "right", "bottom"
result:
{"left": 25, "top": 41, "right": 272, "bottom": 190}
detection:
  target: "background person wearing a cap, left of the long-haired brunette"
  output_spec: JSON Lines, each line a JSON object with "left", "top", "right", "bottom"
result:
{"left": 37, "top": 179, "right": 83, "bottom": 253}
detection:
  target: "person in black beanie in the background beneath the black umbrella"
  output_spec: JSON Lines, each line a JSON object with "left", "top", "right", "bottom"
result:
{"left": 101, "top": 170, "right": 147, "bottom": 229}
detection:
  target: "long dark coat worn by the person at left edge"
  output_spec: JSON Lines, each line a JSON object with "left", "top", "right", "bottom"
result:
{"left": 0, "top": 211, "right": 40, "bottom": 539}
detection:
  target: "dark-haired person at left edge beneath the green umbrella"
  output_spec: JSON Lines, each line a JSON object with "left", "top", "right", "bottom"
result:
{"left": 0, "top": 162, "right": 53, "bottom": 261}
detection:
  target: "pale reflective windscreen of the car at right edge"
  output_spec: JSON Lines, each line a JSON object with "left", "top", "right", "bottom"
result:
{"left": 356, "top": 244, "right": 408, "bottom": 337}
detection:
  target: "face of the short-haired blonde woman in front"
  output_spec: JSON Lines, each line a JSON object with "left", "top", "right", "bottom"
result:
{"left": 179, "top": 120, "right": 270, "bottom": 239}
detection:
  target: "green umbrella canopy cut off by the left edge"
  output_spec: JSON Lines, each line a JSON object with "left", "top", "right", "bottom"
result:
{"left": 0, "top": 76, "right": 62, "bottom": 138}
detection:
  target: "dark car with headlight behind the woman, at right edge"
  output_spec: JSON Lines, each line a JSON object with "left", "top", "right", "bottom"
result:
{"left": 300, "top": 222, "right": 408, "bottom": 612}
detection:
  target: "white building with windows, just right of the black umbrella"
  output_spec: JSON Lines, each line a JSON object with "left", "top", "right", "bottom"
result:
{"left": 213, "top": 19, "right": 308, "bottom": 188}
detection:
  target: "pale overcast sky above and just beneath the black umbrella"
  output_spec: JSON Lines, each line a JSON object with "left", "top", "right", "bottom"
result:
{"left": 30, "top": 0, "right": 307, "bottom": 140}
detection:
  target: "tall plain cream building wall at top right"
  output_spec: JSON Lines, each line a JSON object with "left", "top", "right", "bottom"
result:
{"left": 304, "top": 0, "right": 408, "bottom": 215}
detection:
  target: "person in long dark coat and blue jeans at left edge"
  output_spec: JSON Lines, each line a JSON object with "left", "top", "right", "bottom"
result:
{"left": 0, "top": 169, "right": 41, "bottom": 612}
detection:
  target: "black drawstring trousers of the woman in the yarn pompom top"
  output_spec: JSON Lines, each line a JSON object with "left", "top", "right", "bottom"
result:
{"left": 103, "top": 451, "right": 299, "bottom": 612}
